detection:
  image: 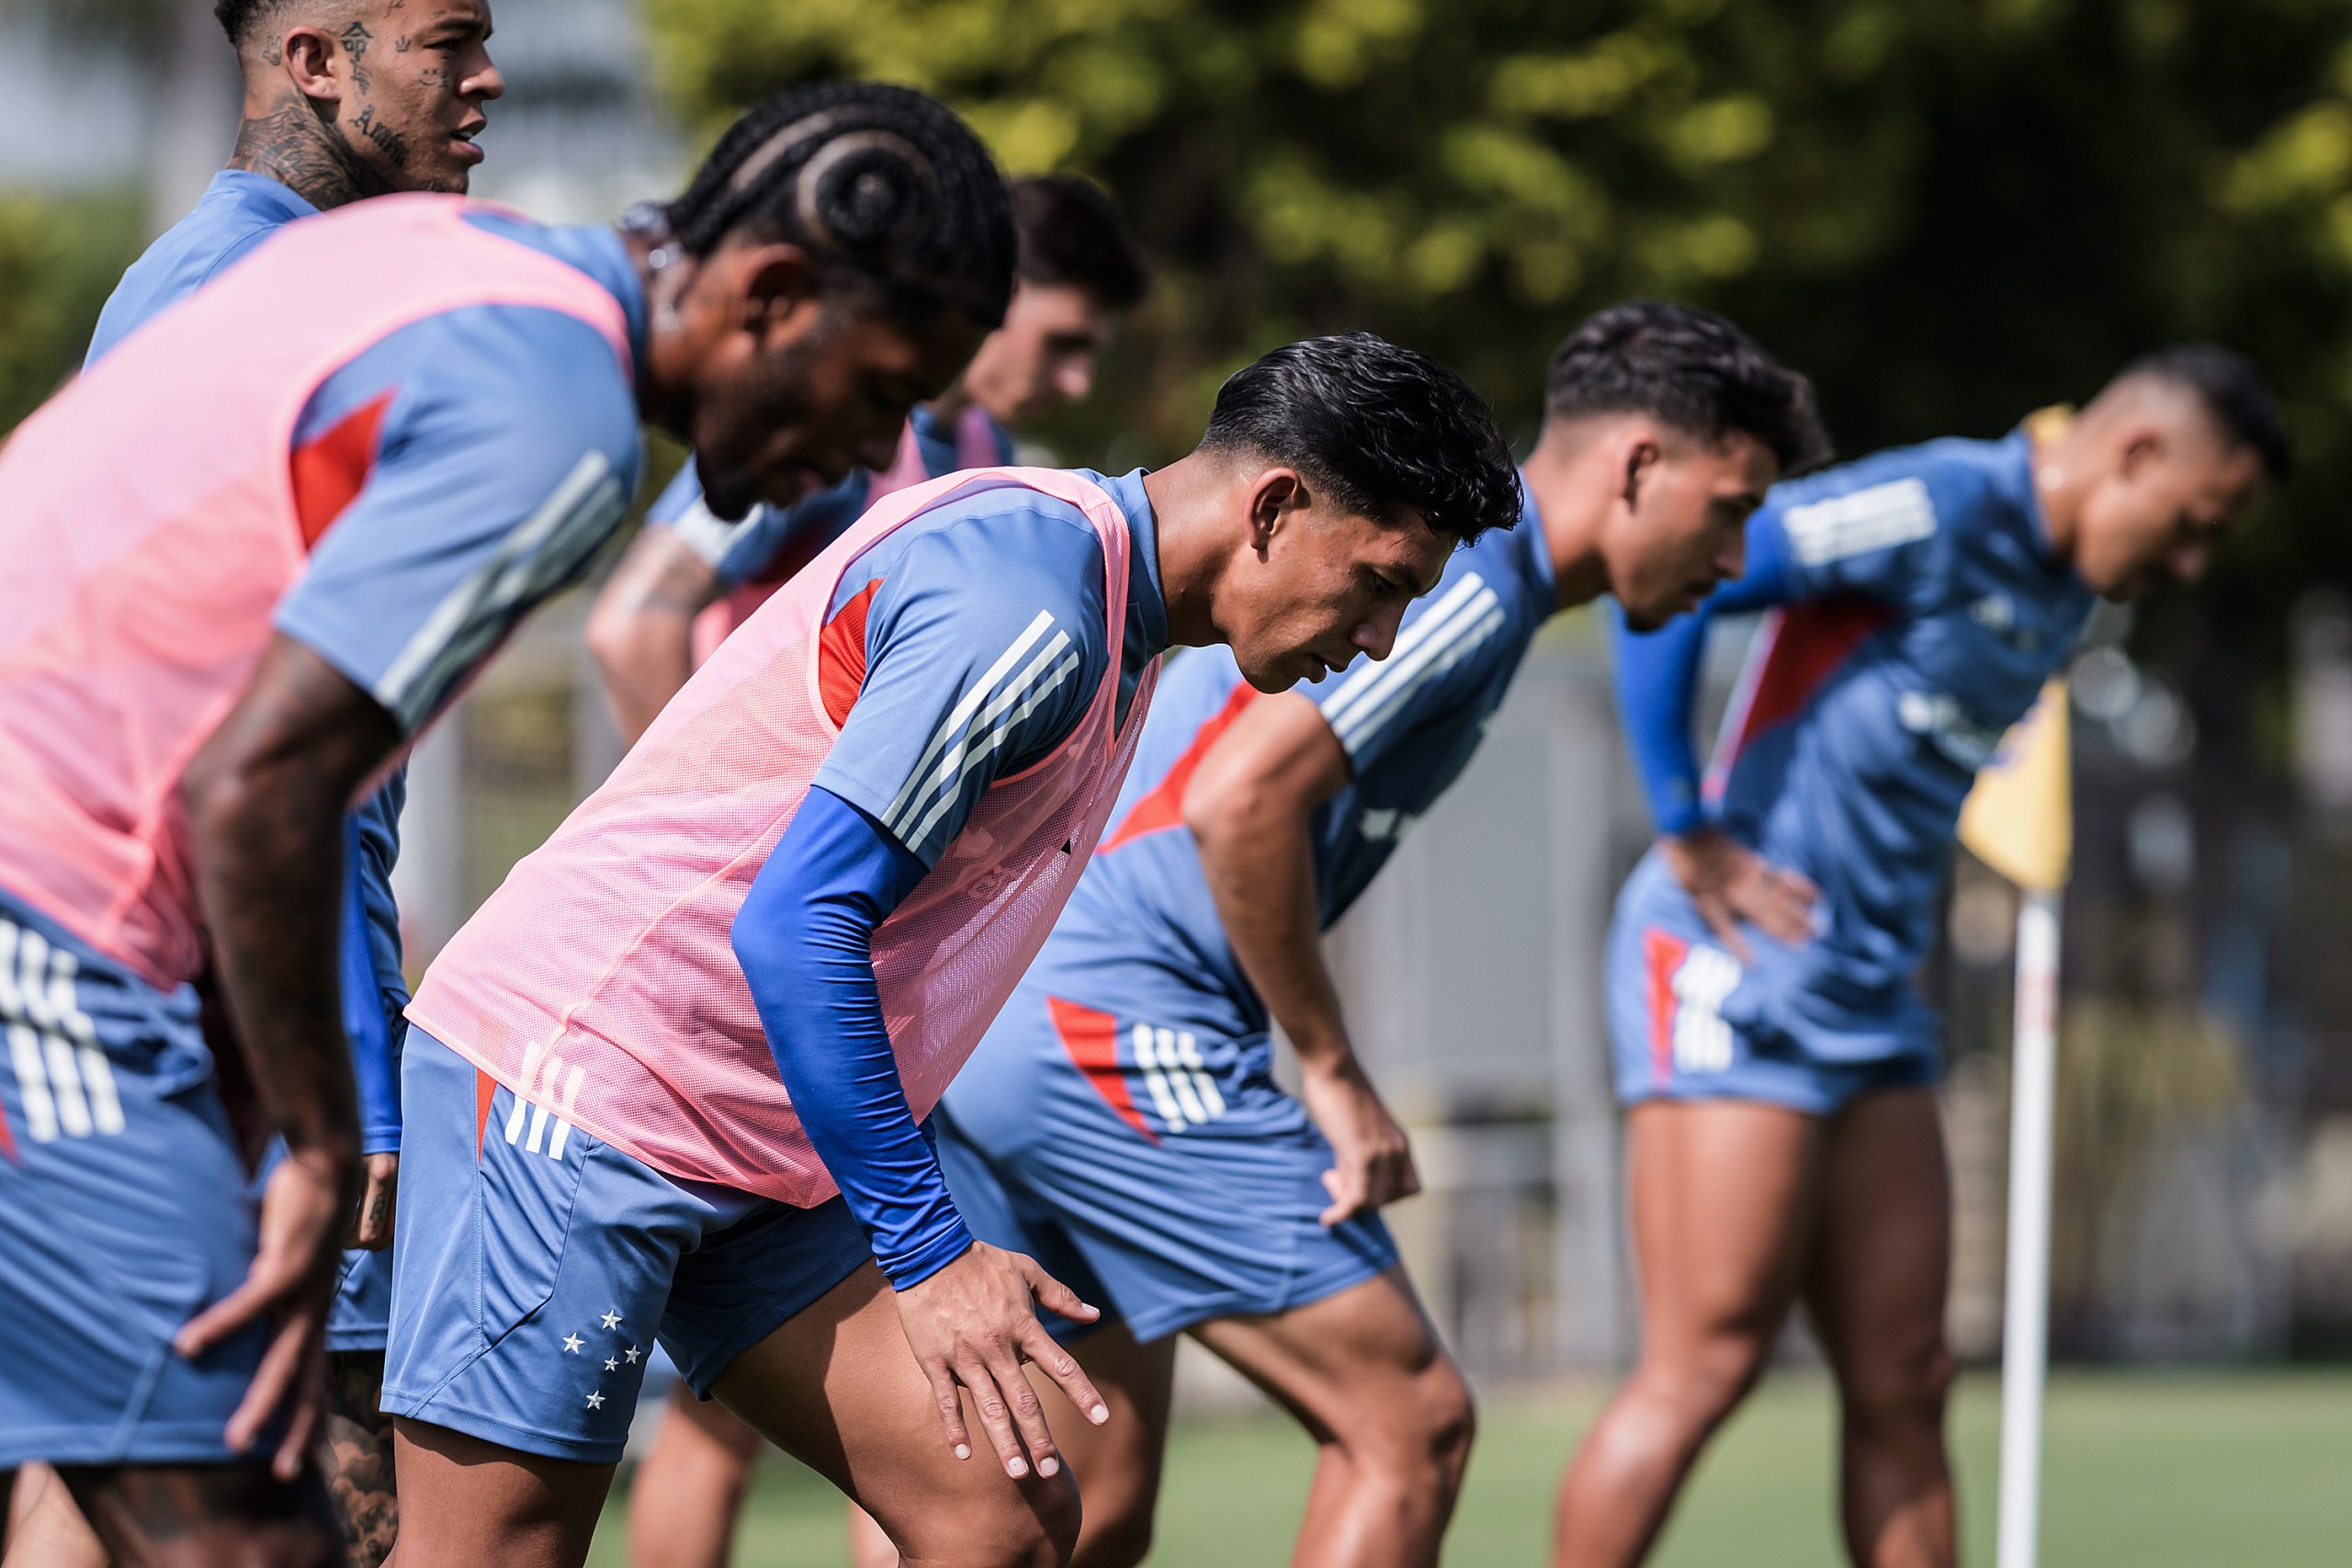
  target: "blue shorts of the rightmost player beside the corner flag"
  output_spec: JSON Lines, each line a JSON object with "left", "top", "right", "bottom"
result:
{"left": 1606, "top": 856, "right": 1943, "bottom": 1117}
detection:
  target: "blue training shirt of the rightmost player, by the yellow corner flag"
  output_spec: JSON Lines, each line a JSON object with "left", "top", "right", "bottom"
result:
{"left": 1616, "top": 430, "right": 2093, "bottom": 1037}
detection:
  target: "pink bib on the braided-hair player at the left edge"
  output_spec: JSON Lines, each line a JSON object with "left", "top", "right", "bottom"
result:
{"left": 0, "top": 195, "right": 630, "bottom": 989}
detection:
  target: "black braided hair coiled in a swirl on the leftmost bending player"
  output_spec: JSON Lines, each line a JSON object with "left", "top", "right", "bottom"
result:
{"left": 663, "top": 83, "right": 1013, "bottom": 329}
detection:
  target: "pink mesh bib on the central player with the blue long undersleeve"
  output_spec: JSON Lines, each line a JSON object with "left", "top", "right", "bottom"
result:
{"left": 409, "top": 468, "right": 1158, "bottom": 1206}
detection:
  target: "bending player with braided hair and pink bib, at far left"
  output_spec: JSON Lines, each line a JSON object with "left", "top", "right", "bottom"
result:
{"left": 0, "top": 85, "right": 1012, "bottom": 1563}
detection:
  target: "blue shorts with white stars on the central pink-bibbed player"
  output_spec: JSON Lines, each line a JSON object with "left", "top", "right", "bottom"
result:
{"left": 383, "top": 1025, "right": 873, "bottom": 1464}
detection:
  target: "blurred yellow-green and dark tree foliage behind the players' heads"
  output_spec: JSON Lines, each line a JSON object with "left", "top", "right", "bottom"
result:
{"left": 647, "top": 0, "right": 2352, "bottom": 677}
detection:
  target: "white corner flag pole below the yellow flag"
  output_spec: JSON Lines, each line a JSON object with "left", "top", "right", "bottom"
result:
{"left": 1995, "top": 891, "right": 2061, "bottom": 1568}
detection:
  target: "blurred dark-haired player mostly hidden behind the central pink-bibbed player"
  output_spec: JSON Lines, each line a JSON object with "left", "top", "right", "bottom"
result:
{"left": 588, "top": 176, "right": 1150, "bottom": 751}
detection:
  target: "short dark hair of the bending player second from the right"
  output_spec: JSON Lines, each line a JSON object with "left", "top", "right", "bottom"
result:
{"left": 1543, "top": 299, "right": 1830, "bottom": 478}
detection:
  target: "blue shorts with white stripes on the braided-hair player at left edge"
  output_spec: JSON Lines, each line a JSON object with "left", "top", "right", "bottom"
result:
{"left": 0, "top": 896, "right": 268, "bottom": 1472}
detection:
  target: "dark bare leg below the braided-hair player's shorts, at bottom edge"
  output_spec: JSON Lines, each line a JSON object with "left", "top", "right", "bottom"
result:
{"left": 56, "top": 1460, "right": 344, "bottom": 1568}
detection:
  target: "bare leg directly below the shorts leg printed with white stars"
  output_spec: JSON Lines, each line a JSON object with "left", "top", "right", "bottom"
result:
{"left": 393, "top": 1416, "right": 614, "bottom": 1568}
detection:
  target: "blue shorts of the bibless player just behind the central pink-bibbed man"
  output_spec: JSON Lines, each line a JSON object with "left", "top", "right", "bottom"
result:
{"left": 933, "top": 980, "right": 1397, "bottom": 1340}
